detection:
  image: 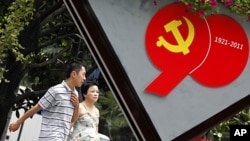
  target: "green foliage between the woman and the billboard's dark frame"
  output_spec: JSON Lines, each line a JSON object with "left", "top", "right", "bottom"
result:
{"left": 97, "top": 89, "right": 135, "bottom": 141}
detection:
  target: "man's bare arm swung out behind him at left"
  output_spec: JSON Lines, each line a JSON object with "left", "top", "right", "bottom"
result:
{"left": 9, "top": 104, "right": 42, "bottom": 132}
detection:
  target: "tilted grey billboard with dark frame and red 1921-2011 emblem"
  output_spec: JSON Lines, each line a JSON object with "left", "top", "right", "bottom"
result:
{"left": 64, "top": 0, "right": 250, "bottom": 141}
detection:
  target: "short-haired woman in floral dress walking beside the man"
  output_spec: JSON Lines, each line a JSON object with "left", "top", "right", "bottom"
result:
{"left": 68, "top": 82, "right": 100, "bottom": 141}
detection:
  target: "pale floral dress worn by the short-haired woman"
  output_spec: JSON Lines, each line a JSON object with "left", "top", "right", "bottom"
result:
{"left": 68, "top": 108, "right": 100, "bottom": 141}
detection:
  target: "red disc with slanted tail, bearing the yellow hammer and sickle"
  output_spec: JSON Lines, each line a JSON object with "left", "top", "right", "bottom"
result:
{"left": 145, "top": 3, "right": 210, "bottom": 96}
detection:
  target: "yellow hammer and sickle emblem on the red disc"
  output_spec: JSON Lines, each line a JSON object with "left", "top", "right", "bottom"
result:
{"left": 156, "top": 16, "right": 194, "bottom": 55}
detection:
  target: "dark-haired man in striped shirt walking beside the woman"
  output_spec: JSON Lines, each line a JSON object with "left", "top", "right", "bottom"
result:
{"left": 9, "top": 62, "right": 86, "bottom": 141}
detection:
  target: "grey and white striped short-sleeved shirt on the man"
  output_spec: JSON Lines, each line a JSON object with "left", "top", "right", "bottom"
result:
{"left": 38, "top": 81, "right": 78, "bottom": 141}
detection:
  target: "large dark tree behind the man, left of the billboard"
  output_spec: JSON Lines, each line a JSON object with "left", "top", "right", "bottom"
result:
{"left": 0, "top": 0, "right": 94, "bottom": 139}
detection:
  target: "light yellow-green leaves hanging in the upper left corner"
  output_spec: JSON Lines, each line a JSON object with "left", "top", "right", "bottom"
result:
{"left": 0, "top": 0, "right": 34, "bottom": 79}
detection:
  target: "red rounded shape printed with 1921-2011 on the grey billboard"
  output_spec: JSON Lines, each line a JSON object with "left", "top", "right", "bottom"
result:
{"left": 191, "top": 15, "right": 249, "bottom": 87}
